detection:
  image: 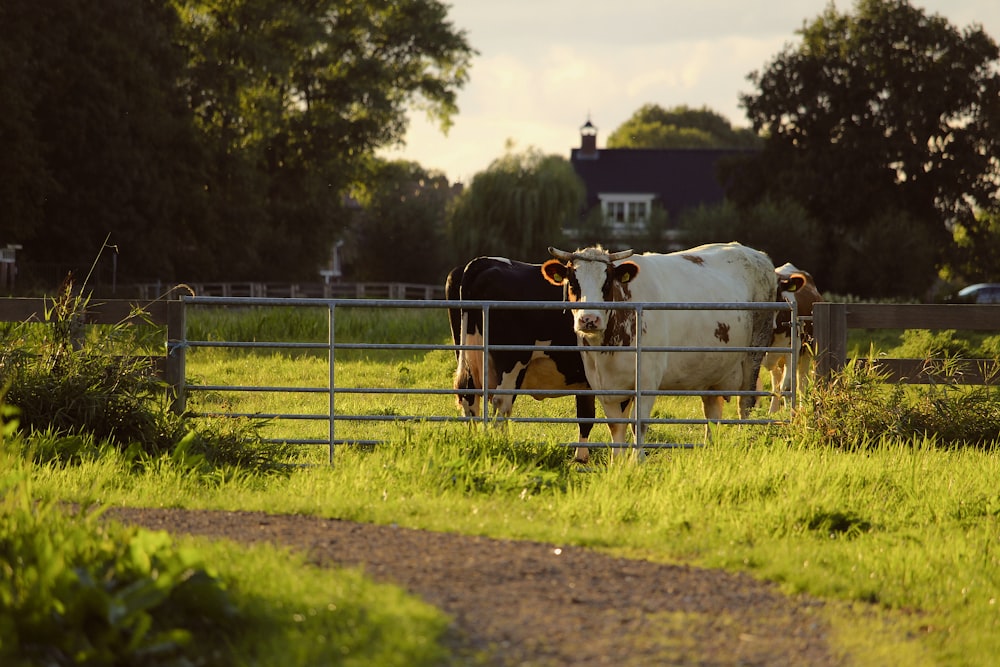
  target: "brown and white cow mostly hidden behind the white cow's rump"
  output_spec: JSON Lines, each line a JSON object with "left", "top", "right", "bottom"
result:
{"left": 761, "top": 263, "right": 823, "bottom": 413}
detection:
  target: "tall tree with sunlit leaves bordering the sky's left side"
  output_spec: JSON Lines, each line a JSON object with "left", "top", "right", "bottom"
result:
{"left": 174, "top": 0, "right": 474, "bottom": 278}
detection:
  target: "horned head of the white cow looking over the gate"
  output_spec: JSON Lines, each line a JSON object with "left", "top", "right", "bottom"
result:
{"left": 542, "top": 246, "right": 639, "bottom": 340}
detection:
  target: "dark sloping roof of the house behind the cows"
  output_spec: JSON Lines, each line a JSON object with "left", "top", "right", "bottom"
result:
{"left": 570, "top": 148, "right": 748, "bottom": 220}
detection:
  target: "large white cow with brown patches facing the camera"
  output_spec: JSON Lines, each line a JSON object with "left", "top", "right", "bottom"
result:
{"left": 542, "top": 243, "right": 776, "bottom": 454}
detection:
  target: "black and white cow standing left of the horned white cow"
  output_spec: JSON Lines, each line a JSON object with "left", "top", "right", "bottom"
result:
{"left": 445, "top": 257, "right": 595, "bottom": 462}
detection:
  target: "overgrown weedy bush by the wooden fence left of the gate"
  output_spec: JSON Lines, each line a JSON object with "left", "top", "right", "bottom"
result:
{"left": 0, "top": 280, "right": 290, "bottom": 469}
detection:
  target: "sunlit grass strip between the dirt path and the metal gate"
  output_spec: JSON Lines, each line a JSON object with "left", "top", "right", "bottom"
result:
{"left": 25, "top": 429, "right": 1000, "bottom": 665}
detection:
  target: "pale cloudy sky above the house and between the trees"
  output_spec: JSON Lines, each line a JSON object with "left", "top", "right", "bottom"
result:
{"left": 380, "top": 0, "right": 1000, "bottom": 183}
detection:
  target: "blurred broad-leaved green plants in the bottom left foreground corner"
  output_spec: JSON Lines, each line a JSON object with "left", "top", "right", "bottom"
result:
{"left": 0, "top": 471, "right": 238, "bottom": 665}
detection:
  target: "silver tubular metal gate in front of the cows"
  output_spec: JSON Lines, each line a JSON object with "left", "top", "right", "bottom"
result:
{"left": 169, "top": 296, "right": 798, "bottom": 463}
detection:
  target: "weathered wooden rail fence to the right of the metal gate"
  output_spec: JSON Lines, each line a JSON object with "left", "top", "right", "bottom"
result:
{"left": 813, "top": 302, "right": 1000, "bottom": 384}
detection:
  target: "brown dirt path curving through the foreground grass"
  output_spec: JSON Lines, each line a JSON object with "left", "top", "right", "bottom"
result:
{"left": 107, "top": 508, "right": 842, "bottom": 667}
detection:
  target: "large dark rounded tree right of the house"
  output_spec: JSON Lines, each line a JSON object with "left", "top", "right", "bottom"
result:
{"left": 727, "top": 0, "right": 1000, "bottom": 295}
